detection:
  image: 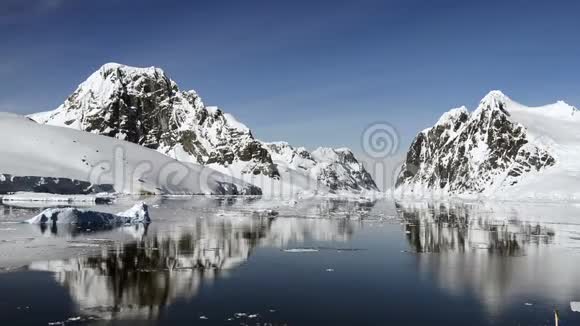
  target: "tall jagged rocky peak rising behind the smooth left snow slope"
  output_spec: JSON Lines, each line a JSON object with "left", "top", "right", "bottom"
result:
{"left": 31, "top": 63, "right": 279, "bottom": 178}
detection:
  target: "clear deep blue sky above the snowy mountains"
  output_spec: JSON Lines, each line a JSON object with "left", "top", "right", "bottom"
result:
{"left": 0, "top": 0, "right": 580, "bottom": 154}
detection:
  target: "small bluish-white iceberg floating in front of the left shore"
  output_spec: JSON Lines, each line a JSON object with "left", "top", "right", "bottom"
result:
{"left": 25, "top": 203, "right": 151, "bottom": 228}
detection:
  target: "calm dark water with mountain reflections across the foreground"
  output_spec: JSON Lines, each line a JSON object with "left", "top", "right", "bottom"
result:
{"left": 0, "top": 197, "right": 580, "bottom": 325}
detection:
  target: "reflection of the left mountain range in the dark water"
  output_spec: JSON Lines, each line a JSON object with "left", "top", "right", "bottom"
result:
{"left": 28, "top": 209, "right": 354, "bottom": 319}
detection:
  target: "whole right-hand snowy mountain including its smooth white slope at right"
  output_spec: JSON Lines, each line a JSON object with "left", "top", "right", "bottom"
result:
{"left": 396, "top": 91, "right": 580, "bottom": 199}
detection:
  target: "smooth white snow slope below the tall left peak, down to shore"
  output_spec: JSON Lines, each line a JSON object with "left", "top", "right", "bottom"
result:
{"left": 0, "top": 113, "right": 260, "bottom": 194}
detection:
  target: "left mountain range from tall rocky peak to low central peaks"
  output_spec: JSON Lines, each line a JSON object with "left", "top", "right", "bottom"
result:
{"left": 30, "top": 63, "right": 377, "bottom": 193}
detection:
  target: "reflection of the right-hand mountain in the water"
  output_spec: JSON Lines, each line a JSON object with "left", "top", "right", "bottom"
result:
{"left": 397, "top": 203, "right": 580, "bottom": 315}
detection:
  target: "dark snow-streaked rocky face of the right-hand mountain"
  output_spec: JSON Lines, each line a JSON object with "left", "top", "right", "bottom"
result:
{"left": 396, "top": 92, "right": 556, "bottom": 193}
